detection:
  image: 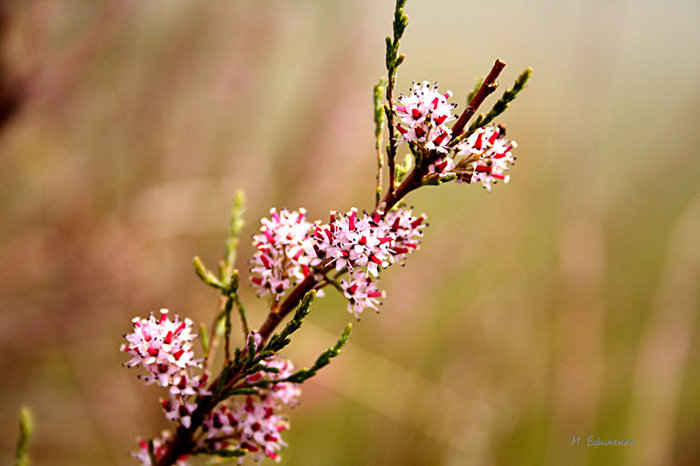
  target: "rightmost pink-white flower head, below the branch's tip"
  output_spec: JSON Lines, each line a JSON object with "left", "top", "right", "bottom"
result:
{"left": 456, "top": 125, "right": 517, "bottom": 192}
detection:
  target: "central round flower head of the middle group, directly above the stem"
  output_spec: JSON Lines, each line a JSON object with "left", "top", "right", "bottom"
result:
{"left": 309, "top": 209, "right": 393, "bottom": 277}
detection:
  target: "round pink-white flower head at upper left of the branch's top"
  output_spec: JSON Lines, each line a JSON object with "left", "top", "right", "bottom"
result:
{"left": 395, "top": 81, "right": 456, "bottom": 152}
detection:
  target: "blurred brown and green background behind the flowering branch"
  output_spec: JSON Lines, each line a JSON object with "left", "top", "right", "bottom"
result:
{"left": 0, "top": 0, "right": 700, "bottom": 465}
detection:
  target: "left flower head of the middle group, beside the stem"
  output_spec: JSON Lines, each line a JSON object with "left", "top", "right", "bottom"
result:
{"left": 250, "top": 209, "right": 312, "bottom": 300}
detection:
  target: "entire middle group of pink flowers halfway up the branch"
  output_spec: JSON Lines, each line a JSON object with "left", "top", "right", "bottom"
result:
{"left": 251, "top": 208, "right": 425, "bottom": 317}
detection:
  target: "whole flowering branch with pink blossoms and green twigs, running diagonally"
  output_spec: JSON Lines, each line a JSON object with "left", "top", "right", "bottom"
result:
{"left": 122, "top": 0, "right": 530, "bottom": 466}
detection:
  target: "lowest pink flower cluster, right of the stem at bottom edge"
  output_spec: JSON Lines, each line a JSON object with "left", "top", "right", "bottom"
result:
{"left": 203, "top": 358, "right": 301, "bottom": 461}
